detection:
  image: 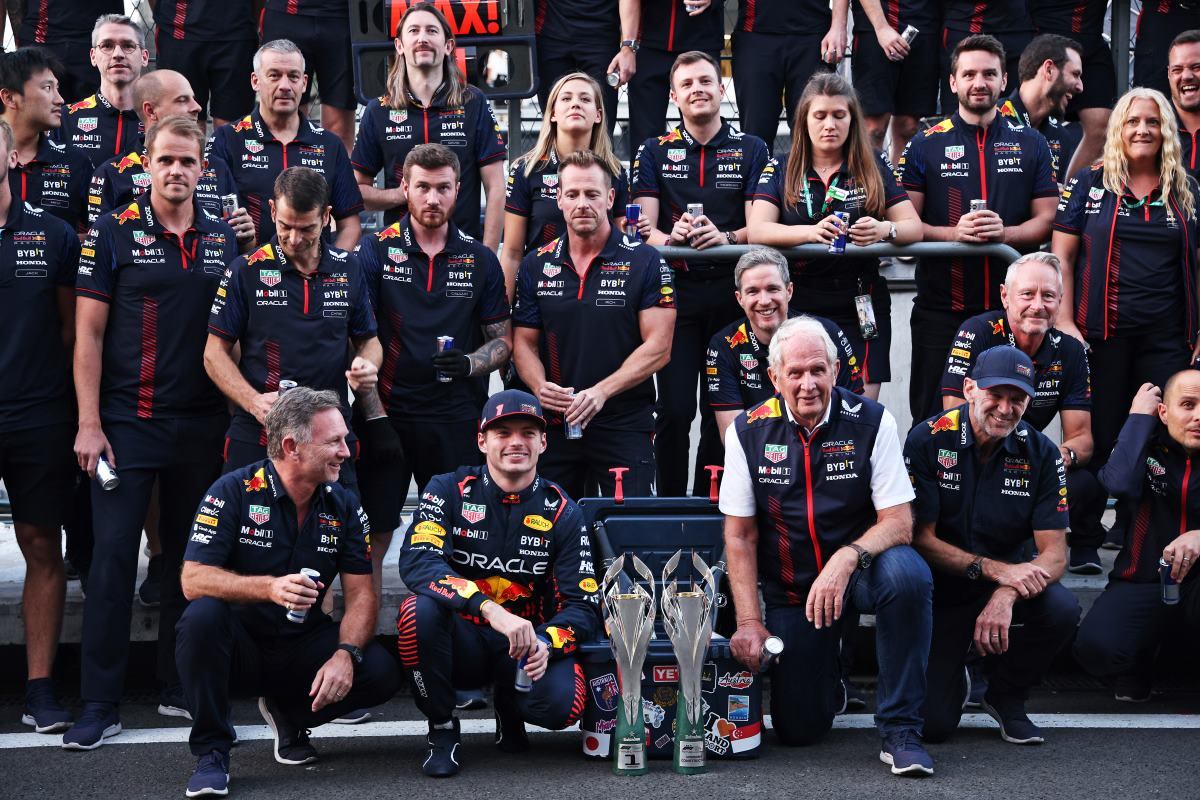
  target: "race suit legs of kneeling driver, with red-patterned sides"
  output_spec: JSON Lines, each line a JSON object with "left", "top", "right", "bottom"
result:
{"left": 396, "top": 595, "right": 587, "bottom": 730}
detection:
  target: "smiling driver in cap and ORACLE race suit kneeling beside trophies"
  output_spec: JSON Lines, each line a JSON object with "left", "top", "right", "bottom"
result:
{"left": 396, "top": 390, "right": 600, "bottom": 777}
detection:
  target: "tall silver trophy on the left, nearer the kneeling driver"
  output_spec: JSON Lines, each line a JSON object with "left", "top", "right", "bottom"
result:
{"left": 601, "top": 555, "right": 655, "bottom": 775}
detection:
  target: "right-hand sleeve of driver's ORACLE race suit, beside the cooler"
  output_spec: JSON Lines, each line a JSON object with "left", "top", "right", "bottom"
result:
{"left": 536, "top": 495, "right": 600, "bottom": 660}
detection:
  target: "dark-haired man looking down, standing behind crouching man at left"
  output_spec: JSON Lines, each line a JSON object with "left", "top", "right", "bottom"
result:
{"left": 204, "top": 167, "right": 382, "bottom": 487}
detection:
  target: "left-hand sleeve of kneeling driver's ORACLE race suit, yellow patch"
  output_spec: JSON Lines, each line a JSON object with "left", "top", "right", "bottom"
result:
{"left": 398, "top": 475, "right": 487, "bottom": 616}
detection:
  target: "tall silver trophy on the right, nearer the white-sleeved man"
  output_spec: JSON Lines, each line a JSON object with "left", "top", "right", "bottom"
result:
{"left": 662, "top": 551, "right": 716, "bottom": 775}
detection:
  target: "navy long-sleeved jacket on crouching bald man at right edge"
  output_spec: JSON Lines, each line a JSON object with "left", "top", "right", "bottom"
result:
{"left": 1099, "top": 414, "right": 1200, "bottom": 583}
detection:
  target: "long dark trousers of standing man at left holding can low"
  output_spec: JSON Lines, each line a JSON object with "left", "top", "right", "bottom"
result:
{"left": 80, "top": 414, "right": 228, "bottom": 703}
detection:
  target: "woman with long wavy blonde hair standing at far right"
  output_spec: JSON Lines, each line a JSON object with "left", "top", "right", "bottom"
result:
{"left": 1051, "top": 88, "right": 1198, "bottom": 546}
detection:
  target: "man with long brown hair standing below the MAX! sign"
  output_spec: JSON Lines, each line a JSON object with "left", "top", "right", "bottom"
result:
{"left": 350, "top": 4, "right": 508, "bottom": 249}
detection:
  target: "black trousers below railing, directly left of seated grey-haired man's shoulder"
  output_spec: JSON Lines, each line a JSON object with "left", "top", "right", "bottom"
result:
{"left": 654, "top": 270, "right": 742, "bottom": 498}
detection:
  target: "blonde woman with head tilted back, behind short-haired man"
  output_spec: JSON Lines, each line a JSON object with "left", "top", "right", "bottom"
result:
{"left": 500, "top": 72, "right": 629, "bottom": 300}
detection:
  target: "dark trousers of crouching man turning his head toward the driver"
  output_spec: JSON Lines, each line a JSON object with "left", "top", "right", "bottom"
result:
{"left": 175, "top": 597, "right": 400, "bottom": 756}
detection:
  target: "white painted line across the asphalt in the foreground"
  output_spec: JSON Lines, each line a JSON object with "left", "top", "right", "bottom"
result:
{"left": 0, "top": 714, "right": 1200, "bottom": 750}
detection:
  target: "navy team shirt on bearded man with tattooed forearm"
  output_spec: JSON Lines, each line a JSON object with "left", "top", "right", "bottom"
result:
{"left": 358, "top": 215, "right": 510, "bottom": 422}
